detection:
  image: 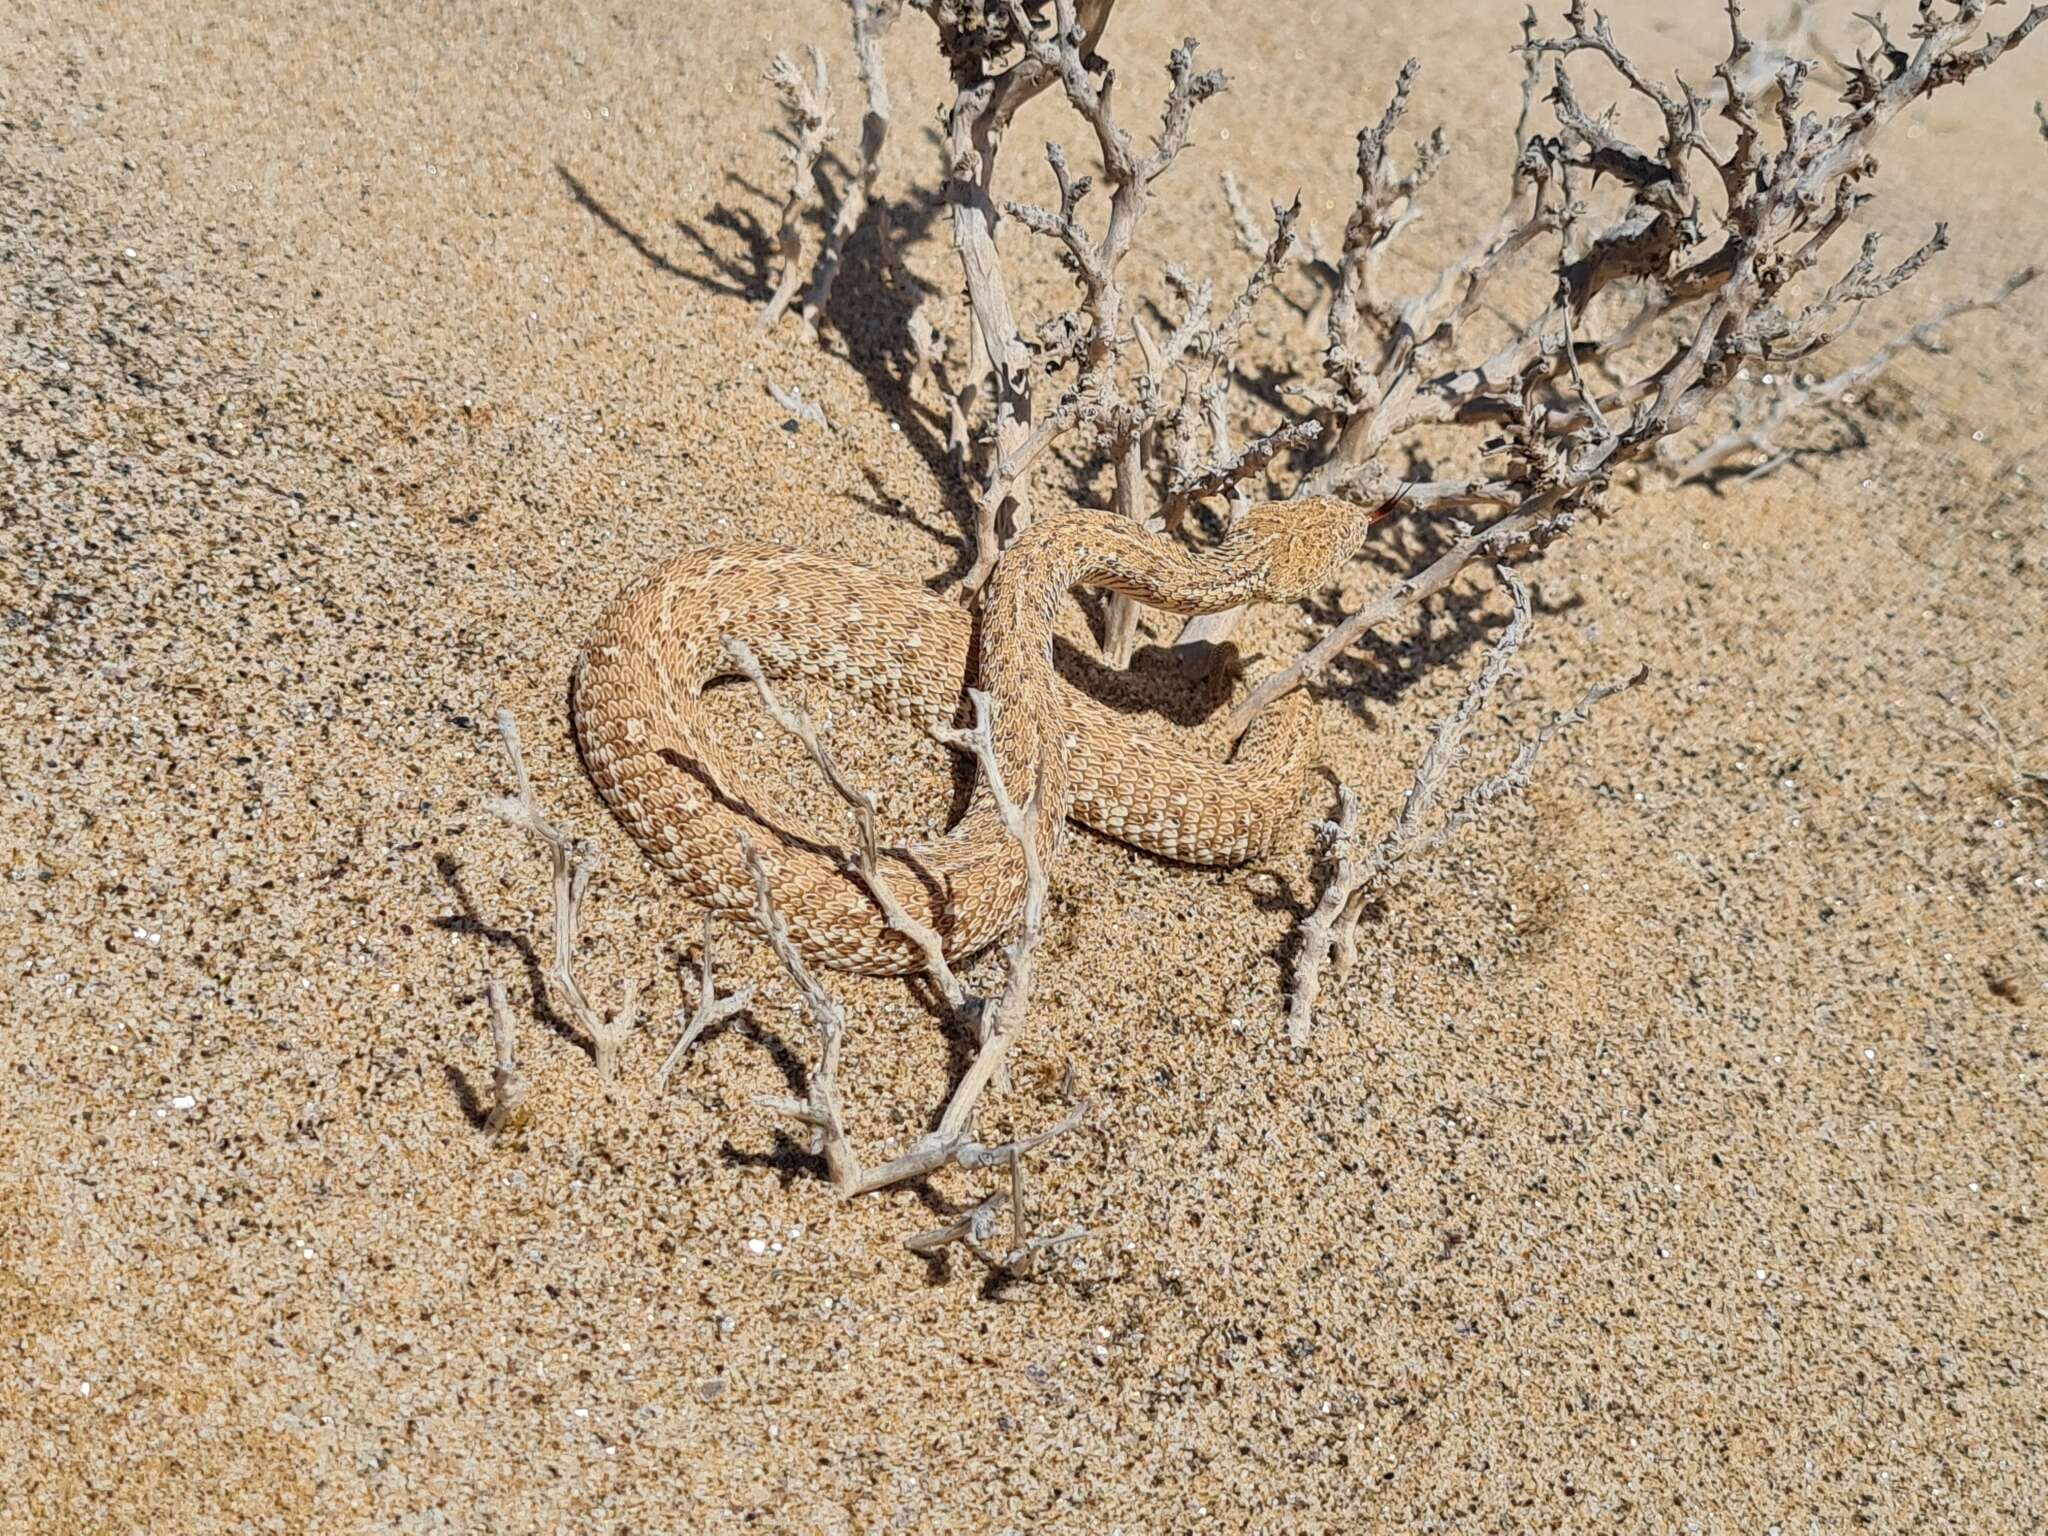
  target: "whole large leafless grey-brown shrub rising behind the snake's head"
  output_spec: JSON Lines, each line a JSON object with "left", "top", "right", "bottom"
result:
{"left": 815, "top": 0, "right": 2048, "bottom": 696}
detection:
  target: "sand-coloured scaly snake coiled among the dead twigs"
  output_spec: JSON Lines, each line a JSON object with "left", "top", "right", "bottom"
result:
{"left": 571, "top": 500, "right": 1374, "bottom": 975}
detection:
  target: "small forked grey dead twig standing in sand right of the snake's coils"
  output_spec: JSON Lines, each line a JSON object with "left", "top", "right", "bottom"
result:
{"left": 1288, "top": 565, "right": 1649, "bottom": 1047}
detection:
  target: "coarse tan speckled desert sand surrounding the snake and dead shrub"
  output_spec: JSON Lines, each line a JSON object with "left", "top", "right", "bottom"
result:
{"left": 0, "top": 0, "right": 2048, "bottom": 1534}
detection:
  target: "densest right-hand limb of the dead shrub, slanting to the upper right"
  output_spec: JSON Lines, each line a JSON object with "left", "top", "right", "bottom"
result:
{"left": 1233, "top": 0, "right": 2048, "bottom": 725}
